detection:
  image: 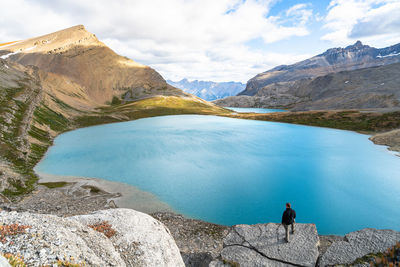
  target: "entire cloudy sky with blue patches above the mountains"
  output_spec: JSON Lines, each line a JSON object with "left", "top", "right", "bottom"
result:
{"left": 0, "top": 0, "right": 400, "bottom": 82}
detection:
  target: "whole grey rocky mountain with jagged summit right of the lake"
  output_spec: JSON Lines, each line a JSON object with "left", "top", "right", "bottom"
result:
{"left": 215, "top": 41, "right": 400, "bottom": 110}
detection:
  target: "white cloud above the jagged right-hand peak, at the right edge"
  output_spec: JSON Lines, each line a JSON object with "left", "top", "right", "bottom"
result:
{"left": 322, "top": 0, "right": 400, "bottom": 47}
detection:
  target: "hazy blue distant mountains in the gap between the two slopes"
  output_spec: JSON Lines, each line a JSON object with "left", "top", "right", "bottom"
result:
{"left": 167, "top": 79, "right": 246, "bottom": 101}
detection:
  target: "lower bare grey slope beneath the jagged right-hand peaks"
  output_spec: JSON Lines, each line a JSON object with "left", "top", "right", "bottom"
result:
{"left": 214, "top": 63, "right": 400, "bottom": 110}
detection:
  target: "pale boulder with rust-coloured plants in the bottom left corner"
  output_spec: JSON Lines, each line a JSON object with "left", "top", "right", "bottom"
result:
{"left": 0, "top": 211, "right": 126, "bottom": 266}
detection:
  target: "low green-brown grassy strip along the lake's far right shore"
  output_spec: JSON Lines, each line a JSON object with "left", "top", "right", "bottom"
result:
{"left": 229, "top": 110, "right": 400, "bottom": 133}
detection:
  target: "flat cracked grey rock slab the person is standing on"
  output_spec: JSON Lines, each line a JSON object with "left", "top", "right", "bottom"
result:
{"left": 217, "top": 223, "right": 319, "bottom": 266}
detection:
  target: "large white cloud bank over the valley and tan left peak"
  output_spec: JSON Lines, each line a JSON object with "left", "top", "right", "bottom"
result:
{"left": 0, "top": 0, "right": 312, "bottom": 81}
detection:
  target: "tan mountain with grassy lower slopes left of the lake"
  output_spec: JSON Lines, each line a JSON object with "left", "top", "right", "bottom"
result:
{"left": 0, "top": 25, "right": 229, "bottom": 202}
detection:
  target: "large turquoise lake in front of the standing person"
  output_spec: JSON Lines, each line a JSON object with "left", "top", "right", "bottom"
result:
{"left": 35, "top": 115, "right": 400, "bottom": 234}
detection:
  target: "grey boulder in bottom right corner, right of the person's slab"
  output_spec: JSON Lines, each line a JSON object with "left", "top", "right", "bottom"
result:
{"left": 320, "top": 228, "right": 400, "bottom": 267}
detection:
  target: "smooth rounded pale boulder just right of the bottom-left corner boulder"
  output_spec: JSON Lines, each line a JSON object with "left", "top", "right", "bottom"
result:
{"left": 71, "top": 209, "right": 185, "bottom": 267}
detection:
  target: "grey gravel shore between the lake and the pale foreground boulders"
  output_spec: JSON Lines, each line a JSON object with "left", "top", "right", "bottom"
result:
{"left": 0, "top": 173, "right": 344, "bottom": 266}
